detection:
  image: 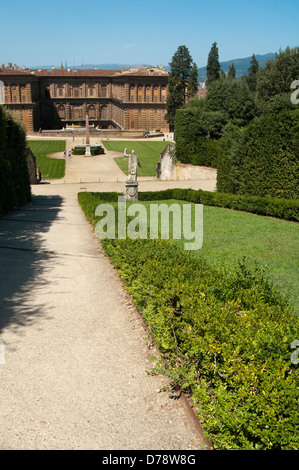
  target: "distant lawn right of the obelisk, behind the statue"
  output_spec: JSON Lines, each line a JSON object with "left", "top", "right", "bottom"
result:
{"left": 102, "top": 140, "right": 167, "bottom": 176}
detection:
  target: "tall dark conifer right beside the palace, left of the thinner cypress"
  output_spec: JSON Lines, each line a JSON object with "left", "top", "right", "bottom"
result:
{"left": 166, "top": 46, "right": 194, "bottom": 131}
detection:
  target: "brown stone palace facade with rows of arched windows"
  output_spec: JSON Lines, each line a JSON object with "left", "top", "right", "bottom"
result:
{"left": 0, "top": 64, "right": 169, "bottom": 132}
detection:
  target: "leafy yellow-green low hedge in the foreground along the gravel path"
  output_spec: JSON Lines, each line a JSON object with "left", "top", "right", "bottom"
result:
{"left": 79, "top": 189, "right": 299, "bottom": 450}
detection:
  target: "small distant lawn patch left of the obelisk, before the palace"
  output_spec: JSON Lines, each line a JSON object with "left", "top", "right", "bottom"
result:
{"left": 27, "top": 140, "right": 65, "bottom": 179}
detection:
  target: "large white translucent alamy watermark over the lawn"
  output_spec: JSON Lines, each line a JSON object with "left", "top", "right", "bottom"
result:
{"left": 95, "top": 197, "right": 203, "bottom": 250}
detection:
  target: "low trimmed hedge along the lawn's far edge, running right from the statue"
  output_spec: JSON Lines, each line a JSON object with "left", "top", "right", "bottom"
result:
{"left": 139, "top": 189, "right": 299, "bottom": 222}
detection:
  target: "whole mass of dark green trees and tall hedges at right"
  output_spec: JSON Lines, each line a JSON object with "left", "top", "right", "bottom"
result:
{"left": 175, "top": 47, "right": 299, "bottom": 199}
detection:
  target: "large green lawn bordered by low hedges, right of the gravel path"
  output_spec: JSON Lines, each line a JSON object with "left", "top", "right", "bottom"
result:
{"left": 82, "top": 193, "right": 299, "bottom": 311}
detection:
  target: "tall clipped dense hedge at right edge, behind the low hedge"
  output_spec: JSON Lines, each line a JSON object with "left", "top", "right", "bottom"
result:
{"left": 217, "top": 109, "right": 299, "bottom": 199}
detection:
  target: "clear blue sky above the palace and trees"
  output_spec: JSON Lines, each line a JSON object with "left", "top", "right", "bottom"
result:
{"left": 0, "top": 0, "right": 299, "bottom": 67}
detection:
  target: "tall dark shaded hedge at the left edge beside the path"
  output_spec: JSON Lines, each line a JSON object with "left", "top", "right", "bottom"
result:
{"left": 0, "top": 105, "right": 31, "bottom": 214}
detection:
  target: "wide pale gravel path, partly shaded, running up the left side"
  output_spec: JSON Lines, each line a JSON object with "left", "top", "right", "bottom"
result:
{"left": 0, "top": 177, "right": 213, "bottom": 450}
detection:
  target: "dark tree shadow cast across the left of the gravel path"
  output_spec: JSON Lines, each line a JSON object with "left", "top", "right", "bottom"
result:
{"left": 0, "top": 196, "right": 63, "bottom": 334}
